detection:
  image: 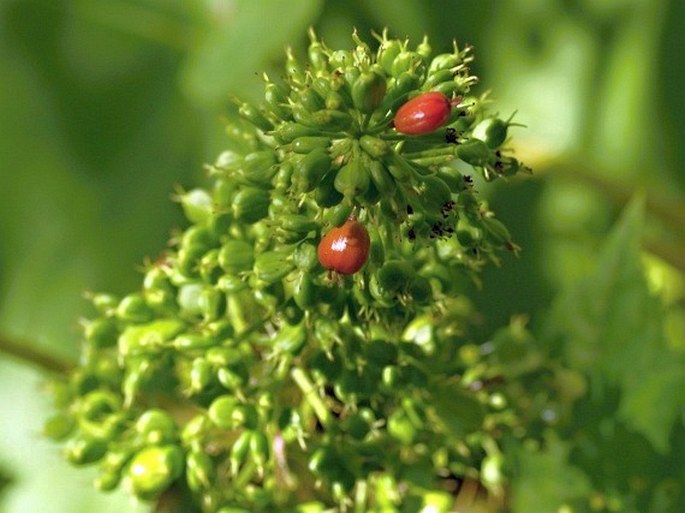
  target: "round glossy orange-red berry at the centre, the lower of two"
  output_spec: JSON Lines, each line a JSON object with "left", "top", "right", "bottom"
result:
{"left": 317, "top": 219, "right": 371, "bottom": 274}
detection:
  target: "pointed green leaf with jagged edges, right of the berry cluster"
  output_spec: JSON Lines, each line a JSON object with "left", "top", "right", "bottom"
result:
{"left": 547, "top": 199, "right": 685, "bottom": 452}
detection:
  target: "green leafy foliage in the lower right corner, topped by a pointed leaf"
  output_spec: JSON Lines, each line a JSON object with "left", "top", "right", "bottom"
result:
{"left": 496, "top": 198, "right": 685, "bottom": 512}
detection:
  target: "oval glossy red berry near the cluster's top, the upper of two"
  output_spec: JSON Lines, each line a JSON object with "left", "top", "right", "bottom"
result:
{"left": 394, "top": 91, "right": 452, "bottom": 135}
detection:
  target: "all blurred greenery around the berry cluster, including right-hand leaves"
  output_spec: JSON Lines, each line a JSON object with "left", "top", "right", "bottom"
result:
{"left": 0, "top": 0, "right": 685, "bottom": 512}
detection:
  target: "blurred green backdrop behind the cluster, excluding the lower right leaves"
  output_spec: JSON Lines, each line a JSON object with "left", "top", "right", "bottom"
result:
{"left": 0, "top": 0, "right": 685, "bottom": 513}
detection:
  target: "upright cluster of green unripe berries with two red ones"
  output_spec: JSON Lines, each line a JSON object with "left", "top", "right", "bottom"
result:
{"left": 46, "top": 33, "right": 525, "bottom": 513}
